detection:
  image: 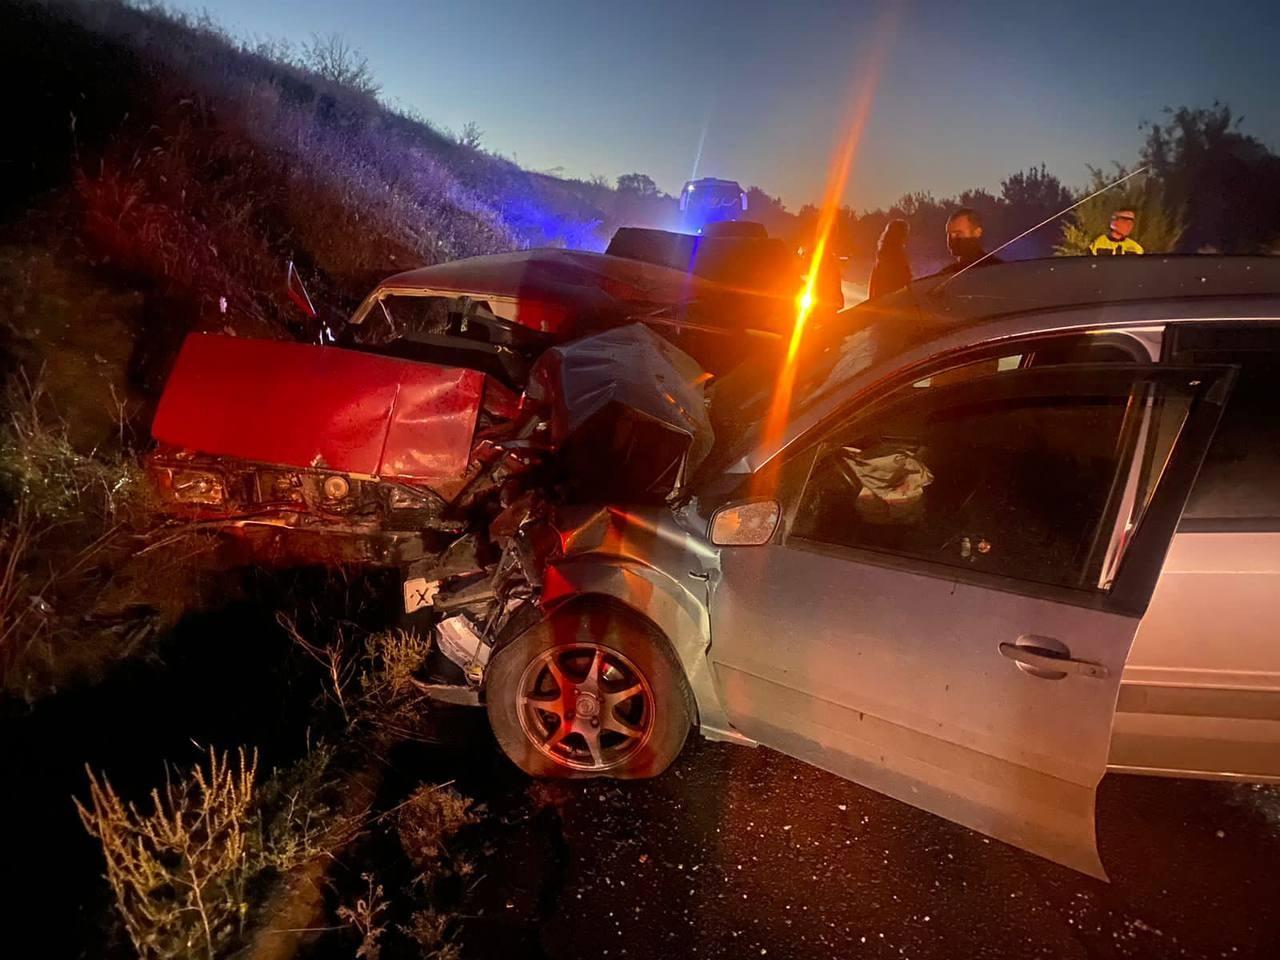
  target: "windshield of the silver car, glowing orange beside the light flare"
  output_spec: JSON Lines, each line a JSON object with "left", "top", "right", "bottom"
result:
{"left": 710, "top": 293, "right": 916, "bottom": 467}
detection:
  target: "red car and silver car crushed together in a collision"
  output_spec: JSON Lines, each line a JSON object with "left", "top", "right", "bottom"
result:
{"left": 151, "top": 241, "right": 1280, "bottom": 877}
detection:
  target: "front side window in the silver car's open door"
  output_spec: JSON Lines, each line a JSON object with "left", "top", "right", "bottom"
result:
{"left": 791, "top": 364, "right": 1188, "bottom": 589}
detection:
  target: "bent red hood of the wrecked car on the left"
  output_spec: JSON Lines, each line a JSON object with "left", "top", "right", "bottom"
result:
{"left": 151, "top": 334, "right": 484, "bottom": 483}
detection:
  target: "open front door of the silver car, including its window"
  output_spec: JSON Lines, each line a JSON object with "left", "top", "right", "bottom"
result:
{"left": 710, "top": 364, "right": 1231, "bottom": 877}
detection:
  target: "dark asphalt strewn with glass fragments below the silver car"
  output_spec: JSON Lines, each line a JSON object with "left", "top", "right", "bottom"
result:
{"left": 450, "top": 741, "right": 1280, "bottom": 960}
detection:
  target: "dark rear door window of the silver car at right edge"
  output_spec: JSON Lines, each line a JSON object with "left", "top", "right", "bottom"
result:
{"left": 1175, "top": 328, "right": 1280, "bottom": 521}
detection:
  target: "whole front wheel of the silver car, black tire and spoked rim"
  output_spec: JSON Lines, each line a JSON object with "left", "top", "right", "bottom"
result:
{"left": 485, "top": 602, "right": 694, "bottom": 780}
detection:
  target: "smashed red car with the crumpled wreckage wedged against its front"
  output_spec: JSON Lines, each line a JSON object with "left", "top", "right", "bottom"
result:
{"left": 147, "top": 224, "right": 840, "bottom": 701}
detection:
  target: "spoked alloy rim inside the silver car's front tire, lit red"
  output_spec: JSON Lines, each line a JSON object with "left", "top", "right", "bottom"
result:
{"left": 517, "top": 643, "right": 654, "bottom": 772}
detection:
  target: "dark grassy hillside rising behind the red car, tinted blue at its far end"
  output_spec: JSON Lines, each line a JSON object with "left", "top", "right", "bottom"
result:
{"left": 0, "top": 0, "right": 671, "bottom": 699}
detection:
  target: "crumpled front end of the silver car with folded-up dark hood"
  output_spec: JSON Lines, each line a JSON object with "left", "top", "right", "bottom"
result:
{"left": 378, "top": 325, "right": 712, "bottom": 699}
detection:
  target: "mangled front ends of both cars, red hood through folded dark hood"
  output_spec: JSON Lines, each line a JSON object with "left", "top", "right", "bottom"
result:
{"left": 147, "top": 263, "right": 712, "bottom": 701}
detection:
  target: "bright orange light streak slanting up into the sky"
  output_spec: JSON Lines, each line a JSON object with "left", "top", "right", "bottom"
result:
{"left": 762, "top": 9, "right": 900, "bottom": 481}
